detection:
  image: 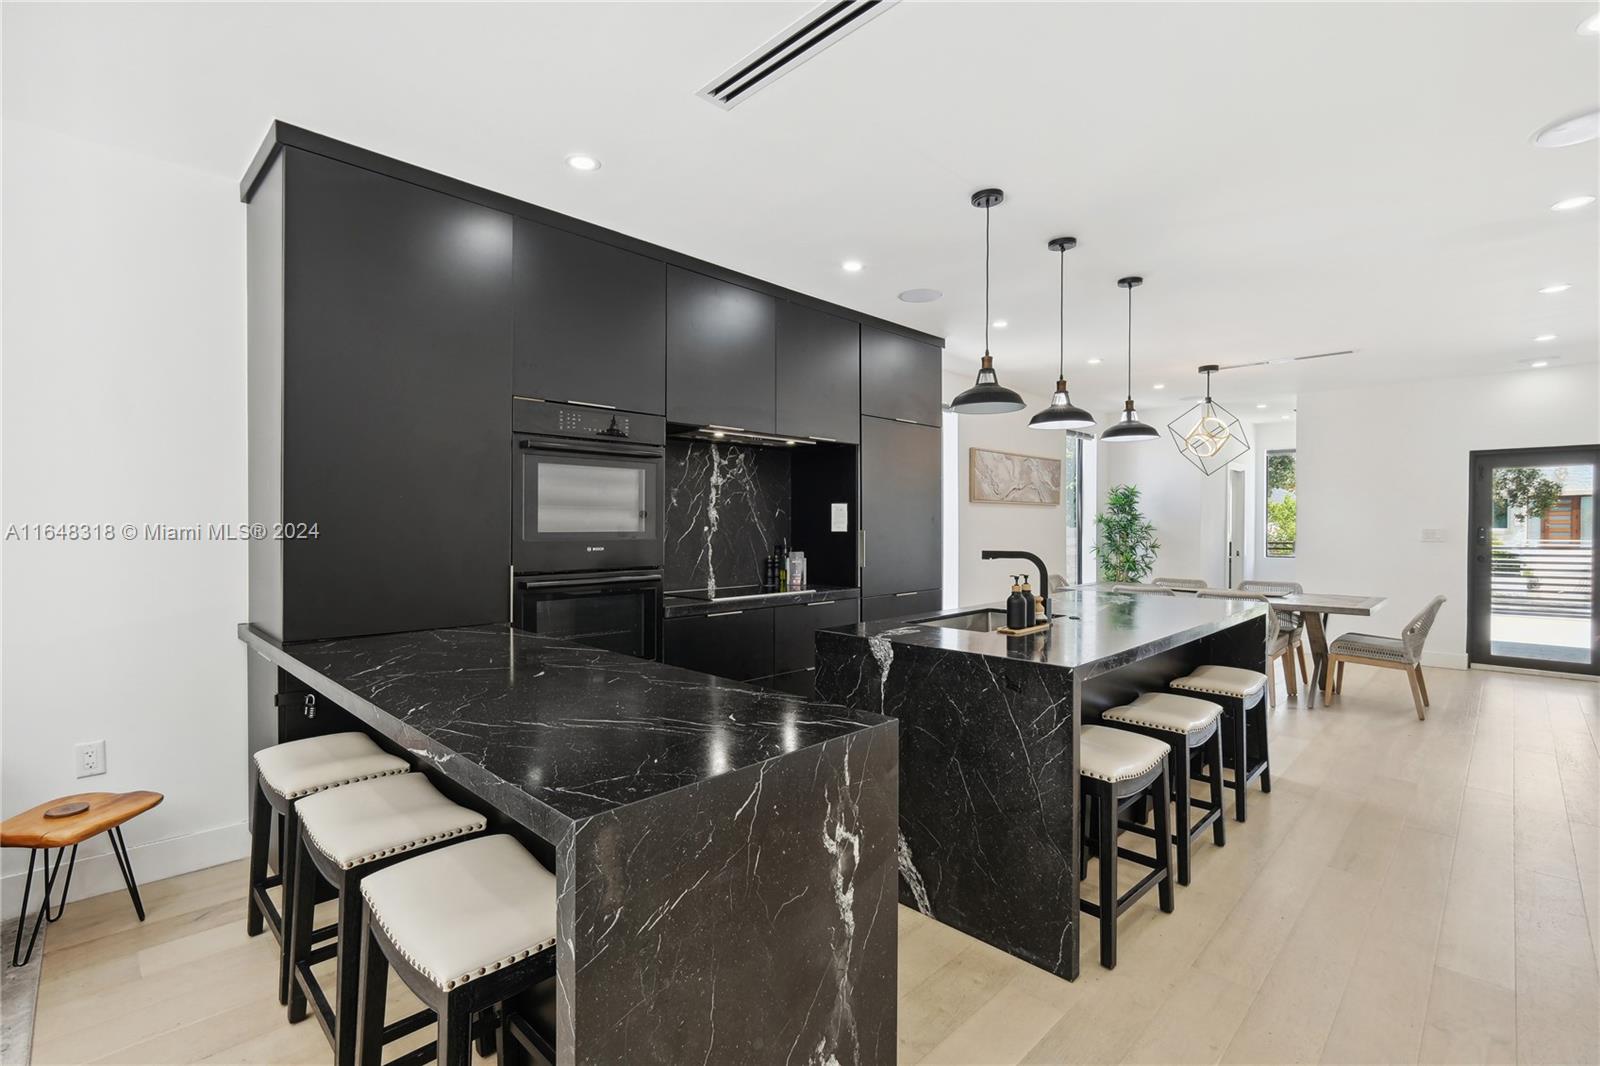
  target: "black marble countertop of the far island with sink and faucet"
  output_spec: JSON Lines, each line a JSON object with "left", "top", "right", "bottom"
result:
{"left": 829, "top": 589, "right": 1266, "bottom": 677}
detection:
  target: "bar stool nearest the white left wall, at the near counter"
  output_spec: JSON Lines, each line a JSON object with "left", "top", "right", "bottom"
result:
{"left": 245, "top": 733, "right": 410, "bottom": 1004}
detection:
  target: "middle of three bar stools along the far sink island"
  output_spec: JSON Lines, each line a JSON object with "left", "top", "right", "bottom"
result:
{"left": 1101, "top": 691, "right": 1227, "bottom": 885}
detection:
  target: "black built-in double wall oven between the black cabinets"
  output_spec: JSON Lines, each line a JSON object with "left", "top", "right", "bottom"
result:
{"left": 512, "top": 397, "right": 667, "bottom": 659}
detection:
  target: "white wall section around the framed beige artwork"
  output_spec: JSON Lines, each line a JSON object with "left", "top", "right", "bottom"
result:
{"left": 944, "top": 373, "right": 1067, "bottom": 607}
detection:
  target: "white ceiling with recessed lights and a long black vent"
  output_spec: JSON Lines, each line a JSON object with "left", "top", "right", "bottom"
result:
{"left": 3, "top": 0, "right": 1600, "bottom": 410}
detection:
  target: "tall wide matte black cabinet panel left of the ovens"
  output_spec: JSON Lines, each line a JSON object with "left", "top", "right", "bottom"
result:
{"left": 283, "top": 149, "right": 512, "bottom": 640}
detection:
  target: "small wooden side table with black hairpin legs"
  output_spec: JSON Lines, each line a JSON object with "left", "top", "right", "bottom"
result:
{"left": 0, "top": 792, "right": 163, "bottom": 967}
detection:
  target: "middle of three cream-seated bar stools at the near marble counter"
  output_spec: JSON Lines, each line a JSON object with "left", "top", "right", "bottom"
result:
{"left": 290, "top": 773, "right": 488, "bottom": 1066}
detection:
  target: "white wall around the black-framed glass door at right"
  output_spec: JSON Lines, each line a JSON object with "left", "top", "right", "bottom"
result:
{"left": 1296, "top": 365, "right": 1600, "bottom": 666}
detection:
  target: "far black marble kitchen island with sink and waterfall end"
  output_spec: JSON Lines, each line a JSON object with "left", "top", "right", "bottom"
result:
{"left": 816, "top": 591, "right": 1266, "bottom": 980}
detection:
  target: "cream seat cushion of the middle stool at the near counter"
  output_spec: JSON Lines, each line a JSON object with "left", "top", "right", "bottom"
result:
{"left": 296, "top": 773, "right": 488, "bottom": 869}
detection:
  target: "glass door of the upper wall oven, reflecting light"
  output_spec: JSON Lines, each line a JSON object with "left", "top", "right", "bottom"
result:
{"left": 515, "top": 447, "right": 664, "bottom": 573}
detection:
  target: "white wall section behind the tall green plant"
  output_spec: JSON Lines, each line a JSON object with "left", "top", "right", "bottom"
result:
{"left": 1083, "top": 407, "right": 1227, "bottom": 586}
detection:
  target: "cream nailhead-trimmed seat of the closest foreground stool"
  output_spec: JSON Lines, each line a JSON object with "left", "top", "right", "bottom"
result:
{"left": 362, "top": 834, "right": 555, "bottom": 991}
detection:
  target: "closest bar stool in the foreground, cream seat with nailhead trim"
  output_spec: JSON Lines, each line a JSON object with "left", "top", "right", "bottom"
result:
{"left": 358, "top": 834, "right": 555, "bottom": 1066}
